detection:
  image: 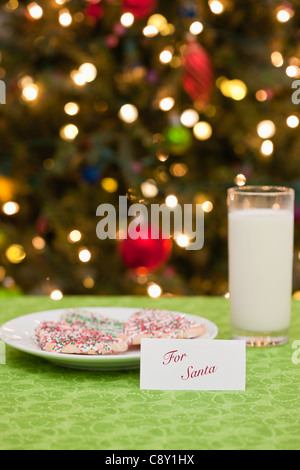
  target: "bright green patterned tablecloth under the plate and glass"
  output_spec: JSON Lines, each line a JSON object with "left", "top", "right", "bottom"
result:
{"left": 0, "top": 297, "right": 300, "bottom": 450}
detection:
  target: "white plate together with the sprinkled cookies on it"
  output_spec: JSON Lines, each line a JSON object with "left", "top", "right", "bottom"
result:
{"left": 0, "top": 307, "right": 218, "bottom": 370}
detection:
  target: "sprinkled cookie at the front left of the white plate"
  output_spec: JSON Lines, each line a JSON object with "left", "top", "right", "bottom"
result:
{"left": 36, "top": 321, "right": 128, "bottom": 355}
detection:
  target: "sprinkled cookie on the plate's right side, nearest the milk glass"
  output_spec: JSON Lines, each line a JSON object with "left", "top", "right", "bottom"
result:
{"left": 120, "top": 309, "right": 206, "bottom": 345}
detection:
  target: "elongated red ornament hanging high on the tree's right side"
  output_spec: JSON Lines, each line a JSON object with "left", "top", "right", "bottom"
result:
{"left": 182, "top": 40, "right": 214, "bottom": 108}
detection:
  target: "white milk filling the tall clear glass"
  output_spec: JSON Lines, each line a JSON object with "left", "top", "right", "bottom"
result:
{"left": 228, "top": 209, "right": 294, "bottom": 332}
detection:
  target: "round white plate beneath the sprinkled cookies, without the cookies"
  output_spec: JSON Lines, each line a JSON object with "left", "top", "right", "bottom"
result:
{"left": 0, "top": 307, "right": 218, "bottom": 370}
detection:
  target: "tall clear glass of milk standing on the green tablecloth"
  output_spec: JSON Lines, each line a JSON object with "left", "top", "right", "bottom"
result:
{"left": 227, "top": 186, "right": 294, "bottom": 346}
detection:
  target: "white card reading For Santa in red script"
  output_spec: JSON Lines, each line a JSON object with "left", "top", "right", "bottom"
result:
{"left": 140, "top": 338, "right": 246, "bottom": 390}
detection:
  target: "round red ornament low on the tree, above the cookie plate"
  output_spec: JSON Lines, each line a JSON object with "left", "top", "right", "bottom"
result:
{"left": 119, "top": 229, "right": 172, "bottom": 271}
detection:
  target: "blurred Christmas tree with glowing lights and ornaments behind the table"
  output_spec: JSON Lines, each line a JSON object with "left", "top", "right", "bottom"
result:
{"left": 0, "top": 0, "right": 300, "bottom": 298}
